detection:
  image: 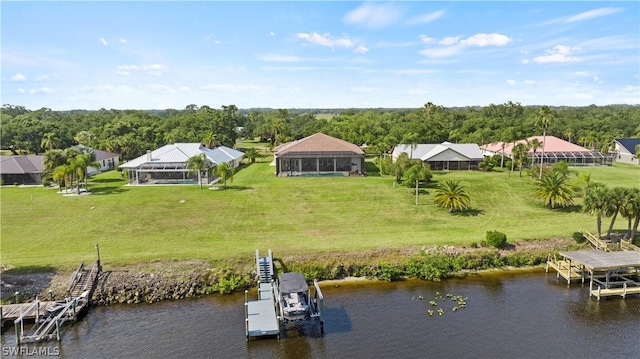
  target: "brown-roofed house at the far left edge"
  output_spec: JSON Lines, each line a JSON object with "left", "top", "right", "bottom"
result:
{"left": 0, "top": 155, "right": 44, "bottom": 185}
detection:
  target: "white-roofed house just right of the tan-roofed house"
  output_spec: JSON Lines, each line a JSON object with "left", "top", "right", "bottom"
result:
{"left": 391, "top": 141, "right": 484, "bottom": 171}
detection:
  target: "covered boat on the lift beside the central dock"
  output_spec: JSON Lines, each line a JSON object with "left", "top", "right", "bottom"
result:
{"left": 278, "top": 272, "right": 311, "bottom": 322}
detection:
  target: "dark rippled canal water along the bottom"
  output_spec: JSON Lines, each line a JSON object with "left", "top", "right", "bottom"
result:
{"left": 2, "top": 272, "right": 640, "bottom": 358}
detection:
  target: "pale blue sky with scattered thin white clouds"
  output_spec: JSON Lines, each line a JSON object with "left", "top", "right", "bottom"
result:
{"left": 0, "top": 1, "right": 640, "bottom": 110}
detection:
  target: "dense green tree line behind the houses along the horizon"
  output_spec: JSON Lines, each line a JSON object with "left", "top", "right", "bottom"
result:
{"left": 0, "top": 101, "right": 640, "bottom": 160}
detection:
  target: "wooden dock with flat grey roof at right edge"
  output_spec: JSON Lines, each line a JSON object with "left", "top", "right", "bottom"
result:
{"left": 547, "top": 250, "right": 640, "bottom": 300}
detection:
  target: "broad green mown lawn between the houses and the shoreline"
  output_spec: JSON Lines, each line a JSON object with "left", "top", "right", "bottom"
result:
{"left": 0, "top": 158, "right": 640, "bottom": 269}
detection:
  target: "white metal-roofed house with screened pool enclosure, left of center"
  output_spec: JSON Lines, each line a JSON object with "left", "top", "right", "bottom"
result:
{"left": 118, "top": 143, "right": 244, "bottom": 185}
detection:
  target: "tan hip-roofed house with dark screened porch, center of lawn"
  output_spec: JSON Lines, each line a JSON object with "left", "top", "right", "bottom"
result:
{"left": 273, "top": 132, "right": 365, "bottom": 177}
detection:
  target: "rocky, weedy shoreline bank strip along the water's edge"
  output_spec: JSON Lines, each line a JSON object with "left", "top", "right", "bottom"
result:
{"left": 2, "top": 239, "right": 578, "bottom": 305}
